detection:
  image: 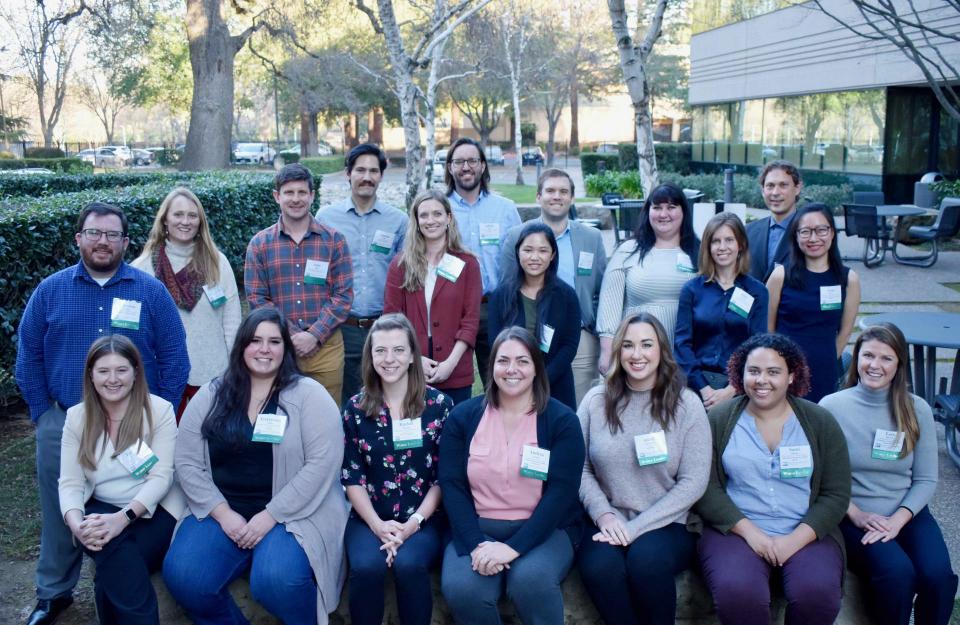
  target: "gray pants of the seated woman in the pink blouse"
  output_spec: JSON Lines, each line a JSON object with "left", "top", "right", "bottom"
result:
{"left": 441, "top": 519, "right": 573, "bottom": 625}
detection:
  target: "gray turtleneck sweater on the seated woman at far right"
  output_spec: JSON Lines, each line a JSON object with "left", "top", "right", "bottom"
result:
{"left": 820, "top": 384, "right": 937, "bottom": 516}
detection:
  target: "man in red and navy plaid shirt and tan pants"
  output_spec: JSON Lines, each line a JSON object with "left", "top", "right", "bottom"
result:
{"left": 243, "top": 163, "right": 353, "bottom": 405}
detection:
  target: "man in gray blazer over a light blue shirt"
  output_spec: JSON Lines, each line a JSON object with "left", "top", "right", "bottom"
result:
{"left": 500, "top": 169, "right": 607, "bottom": 405}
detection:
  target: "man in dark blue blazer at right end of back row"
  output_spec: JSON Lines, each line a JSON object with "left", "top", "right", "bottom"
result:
{"left": 747, "top": 160, "right": 803, "bottom": 282}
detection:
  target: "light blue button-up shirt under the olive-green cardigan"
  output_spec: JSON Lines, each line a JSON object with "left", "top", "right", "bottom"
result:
{"left": 723, "top": 410, "right": 813, "bottom": 536}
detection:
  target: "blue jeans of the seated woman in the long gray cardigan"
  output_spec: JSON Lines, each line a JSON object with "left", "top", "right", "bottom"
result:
{"left": 163, "top": 515, "right": 317, "bottom": 625}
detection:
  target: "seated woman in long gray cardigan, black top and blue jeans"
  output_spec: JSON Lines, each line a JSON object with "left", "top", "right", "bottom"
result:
{"left": 163, "top": 308, "right": 347, "bottom": 625}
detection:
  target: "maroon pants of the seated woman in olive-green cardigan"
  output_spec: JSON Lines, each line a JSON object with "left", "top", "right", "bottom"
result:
{"left": 699, "top": 528, "right": 843, "bottom": 625}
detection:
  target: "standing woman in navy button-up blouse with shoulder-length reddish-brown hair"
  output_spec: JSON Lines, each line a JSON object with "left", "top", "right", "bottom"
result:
{"left": 674, "top": 213, "right": 767, "bottom": 409}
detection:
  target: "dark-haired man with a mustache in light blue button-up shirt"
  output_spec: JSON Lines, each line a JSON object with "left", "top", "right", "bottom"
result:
{"left": 317, "top": 143, "right": 407, "bottom": 406}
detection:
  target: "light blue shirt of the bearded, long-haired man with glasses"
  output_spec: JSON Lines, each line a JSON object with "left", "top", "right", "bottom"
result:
{"left": 450, "top": 191, "right": 520, "bottom": 295}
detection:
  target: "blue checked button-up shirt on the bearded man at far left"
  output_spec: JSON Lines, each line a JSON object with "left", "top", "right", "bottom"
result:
{"left": 17, "top": 262, "right": 190, "bottom": 421}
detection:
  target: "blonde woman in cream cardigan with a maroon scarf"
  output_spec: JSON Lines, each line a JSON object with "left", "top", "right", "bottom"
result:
{"left": 131, "top": 187, "right": 240, "bottom": 420}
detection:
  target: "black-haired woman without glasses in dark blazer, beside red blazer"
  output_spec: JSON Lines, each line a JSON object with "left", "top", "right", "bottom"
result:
{"left": 488, "top": 222, "right": 581, "bottom": 410}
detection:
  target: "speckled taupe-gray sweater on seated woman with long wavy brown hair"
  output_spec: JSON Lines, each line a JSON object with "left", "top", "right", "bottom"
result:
{"left": 577, "top": 385, "right": 711, "bottom": 540}
